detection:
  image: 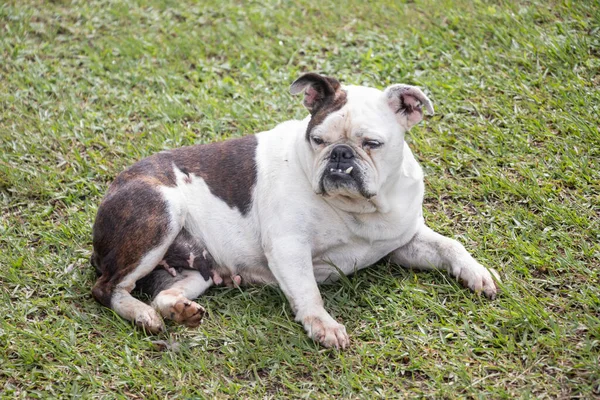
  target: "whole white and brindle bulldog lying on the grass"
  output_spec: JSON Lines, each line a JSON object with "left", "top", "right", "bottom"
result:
{"left": 91, "top": 73, "right": 497, "bottom": 348}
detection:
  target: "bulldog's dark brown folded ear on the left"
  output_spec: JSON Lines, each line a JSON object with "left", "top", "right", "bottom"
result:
{"left": 290, "top": 72, "right": 342, "bottom": 114}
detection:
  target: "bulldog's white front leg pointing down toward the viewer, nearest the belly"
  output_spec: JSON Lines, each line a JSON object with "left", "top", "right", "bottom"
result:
{"left": 266, "top": 237, "right": 350, "bottom": 349}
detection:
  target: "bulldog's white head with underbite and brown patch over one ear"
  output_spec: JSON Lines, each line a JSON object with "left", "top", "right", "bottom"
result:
{"left": 290, "top": 73, "right": 433, "bottom": 208}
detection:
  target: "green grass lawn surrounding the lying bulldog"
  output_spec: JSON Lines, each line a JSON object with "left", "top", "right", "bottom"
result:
{"left": 0, "top": 0, "right": 600, "bottom": 399}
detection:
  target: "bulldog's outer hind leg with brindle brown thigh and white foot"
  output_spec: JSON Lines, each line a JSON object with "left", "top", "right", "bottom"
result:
{"left": 92, "top": 181, "right": 182, "bottom": 333}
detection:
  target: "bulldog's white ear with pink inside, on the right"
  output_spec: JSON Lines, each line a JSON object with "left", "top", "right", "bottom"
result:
{"left": 384, "top": 85, "right": 433, "bottom": 129}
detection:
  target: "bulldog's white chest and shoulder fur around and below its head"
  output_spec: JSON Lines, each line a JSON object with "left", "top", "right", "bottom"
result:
{"left": 248, "top": 121, "right": 423, "bottom": 282}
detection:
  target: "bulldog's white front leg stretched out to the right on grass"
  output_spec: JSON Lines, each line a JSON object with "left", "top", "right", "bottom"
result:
{"left": 391, "top": 224, "right": 498, "bottom": 299}
